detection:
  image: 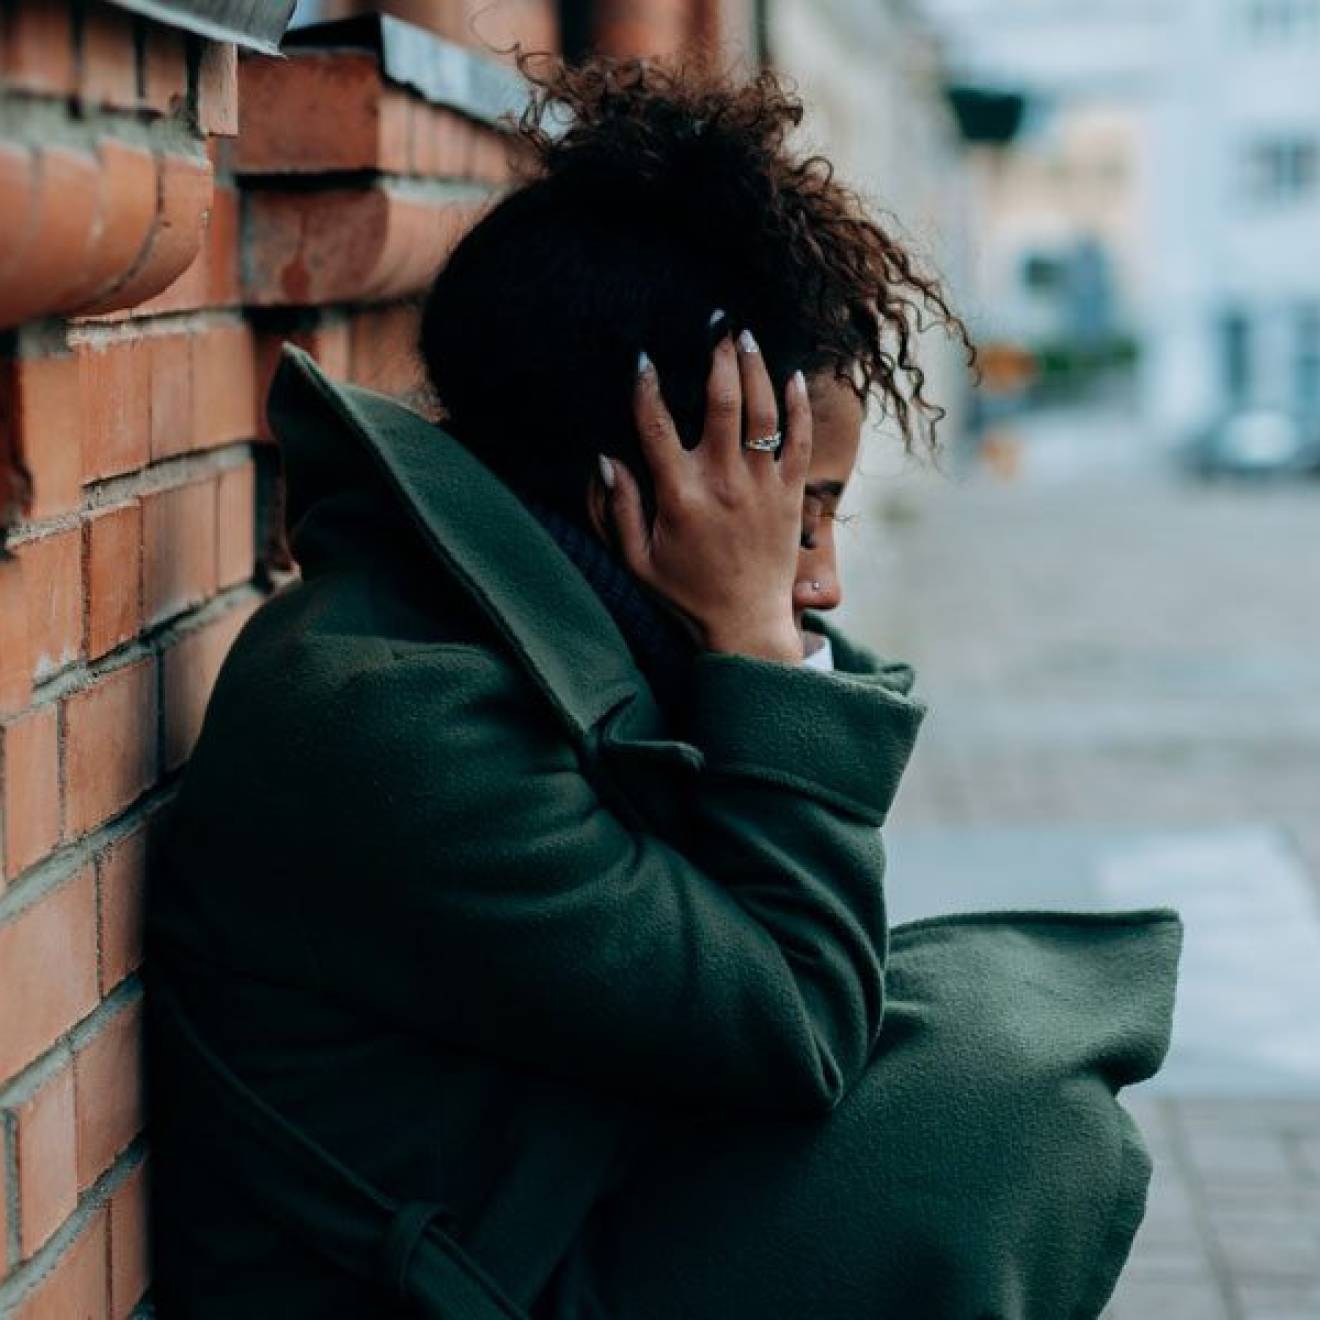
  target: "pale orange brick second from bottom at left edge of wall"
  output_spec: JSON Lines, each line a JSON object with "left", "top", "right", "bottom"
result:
{"left": 13, "top": 1067, "right": 78, "bottom": 1259}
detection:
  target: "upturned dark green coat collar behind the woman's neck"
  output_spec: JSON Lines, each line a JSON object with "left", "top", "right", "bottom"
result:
{"left": 269, "top": 343, "right": 653, "bottom": 739}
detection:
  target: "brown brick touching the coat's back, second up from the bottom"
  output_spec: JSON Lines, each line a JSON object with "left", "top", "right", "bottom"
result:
{"left": 74, "top": 999, "right": 143, "bottom": 1191}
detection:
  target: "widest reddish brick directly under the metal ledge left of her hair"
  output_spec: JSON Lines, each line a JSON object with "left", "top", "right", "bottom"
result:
{"left": 234, "top": 50, "right": 388, "bottom": 174}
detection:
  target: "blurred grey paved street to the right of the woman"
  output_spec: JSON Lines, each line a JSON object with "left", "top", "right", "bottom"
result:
{"left": 840, "top": 408, "right": 1320, "bottom": 1320}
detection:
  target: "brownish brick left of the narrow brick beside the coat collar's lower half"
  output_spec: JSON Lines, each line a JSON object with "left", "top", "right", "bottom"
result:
{"left": 143, "top": 478, "right": 216, "bottom": 624}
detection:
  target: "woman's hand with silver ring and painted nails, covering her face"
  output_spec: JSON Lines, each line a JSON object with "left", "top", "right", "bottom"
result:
{"left": 601, "top": 324, "right": 812, "bottom": 664}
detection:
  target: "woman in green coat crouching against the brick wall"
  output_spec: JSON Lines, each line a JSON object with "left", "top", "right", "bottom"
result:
{"left": 148, "top": 54, "right": 1179, "bottom": 1320}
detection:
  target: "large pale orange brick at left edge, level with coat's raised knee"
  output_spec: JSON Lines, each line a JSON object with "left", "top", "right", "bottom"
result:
{"left": 0, "top": 866, "right": 96, "bottom": 1077}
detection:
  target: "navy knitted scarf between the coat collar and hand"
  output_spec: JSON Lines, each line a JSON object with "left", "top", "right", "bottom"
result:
{"left": 516, "top": 487, "right": 698, "bottom": 729}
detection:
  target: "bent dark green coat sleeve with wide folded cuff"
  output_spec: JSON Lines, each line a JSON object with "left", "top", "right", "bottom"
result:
{"left": 308, "top": 645, "right": 924, "bottom": 1115}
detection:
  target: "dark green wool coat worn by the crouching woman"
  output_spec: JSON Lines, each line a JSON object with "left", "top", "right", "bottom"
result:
{"left": 148, "top": 348, "right": 1179, "bottom": 1320}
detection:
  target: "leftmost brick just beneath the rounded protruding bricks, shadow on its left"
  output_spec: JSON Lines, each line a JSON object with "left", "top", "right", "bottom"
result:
{"left": 0, "top": 354, "right": 83, "bottom": 519}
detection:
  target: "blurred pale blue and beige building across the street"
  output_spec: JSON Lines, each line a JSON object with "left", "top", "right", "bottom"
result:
{"left": 928, "top": 0, "right": 1320, "bottom": 438}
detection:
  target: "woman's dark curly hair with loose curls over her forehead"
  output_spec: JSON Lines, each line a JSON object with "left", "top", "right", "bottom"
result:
{"left": 421, "top": 53, "right": 974, "bottom": 520}
